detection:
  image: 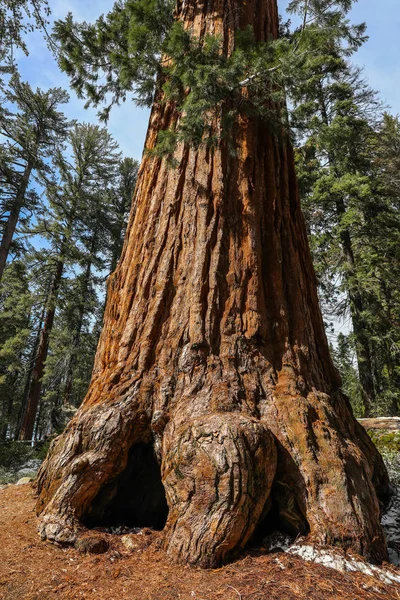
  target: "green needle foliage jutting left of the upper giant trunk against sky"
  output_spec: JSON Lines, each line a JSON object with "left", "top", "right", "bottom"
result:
{"left": 54, "top": 0, "right": 175, "bottom": 117}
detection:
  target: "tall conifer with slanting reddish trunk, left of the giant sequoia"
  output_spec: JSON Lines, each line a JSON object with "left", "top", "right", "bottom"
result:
{"left": 20, "top": 125, "right": 119, "bottom": 439}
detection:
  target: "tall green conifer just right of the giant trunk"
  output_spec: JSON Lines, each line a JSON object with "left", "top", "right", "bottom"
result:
{"left": 291, "top": 62, "right": 399, "bottom": 416}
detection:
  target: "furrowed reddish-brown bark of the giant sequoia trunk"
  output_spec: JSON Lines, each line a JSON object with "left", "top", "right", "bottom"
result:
{"left": 37, "top": 0, "right": 387, "bottom": 566}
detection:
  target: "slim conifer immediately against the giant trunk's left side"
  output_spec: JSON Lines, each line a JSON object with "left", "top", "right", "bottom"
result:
{"left": 45, "top": 158, "right": 138, "bottom": 421}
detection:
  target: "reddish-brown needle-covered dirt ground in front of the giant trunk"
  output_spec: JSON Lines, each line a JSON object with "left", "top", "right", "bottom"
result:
{"left": 0, "top": 485, "right": 400, "bottom": 600}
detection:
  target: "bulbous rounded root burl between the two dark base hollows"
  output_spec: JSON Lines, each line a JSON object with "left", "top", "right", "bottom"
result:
{"left": 163, "top": 414, "right": 276, "bottom": 567}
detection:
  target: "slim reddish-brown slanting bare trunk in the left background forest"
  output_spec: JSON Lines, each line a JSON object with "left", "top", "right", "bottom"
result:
{"left": 19, "top": 259, "right": 64, "bottom": 440}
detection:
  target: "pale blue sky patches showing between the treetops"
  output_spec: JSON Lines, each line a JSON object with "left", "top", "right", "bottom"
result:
{"left": 20, "top": 0, "right": 400, "bottom": 159}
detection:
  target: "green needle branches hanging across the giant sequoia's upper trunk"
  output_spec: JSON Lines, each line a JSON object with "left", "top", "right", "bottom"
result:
{"left": 54, "top": 0, "right": 365, "bottom": 158}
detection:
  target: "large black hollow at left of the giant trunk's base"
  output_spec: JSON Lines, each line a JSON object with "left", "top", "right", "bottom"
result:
{"left": 83, "top": 444, "right": 168, "bottom": 530}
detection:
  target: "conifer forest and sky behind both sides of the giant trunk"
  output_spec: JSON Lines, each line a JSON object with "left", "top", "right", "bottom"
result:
{"left": 0, "top": 0, "right": 400, "bottom": 440}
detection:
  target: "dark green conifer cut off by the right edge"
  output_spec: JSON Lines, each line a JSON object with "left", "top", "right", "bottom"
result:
{"left": 357, "top": 114, "right": 400, "bottom": 415}
